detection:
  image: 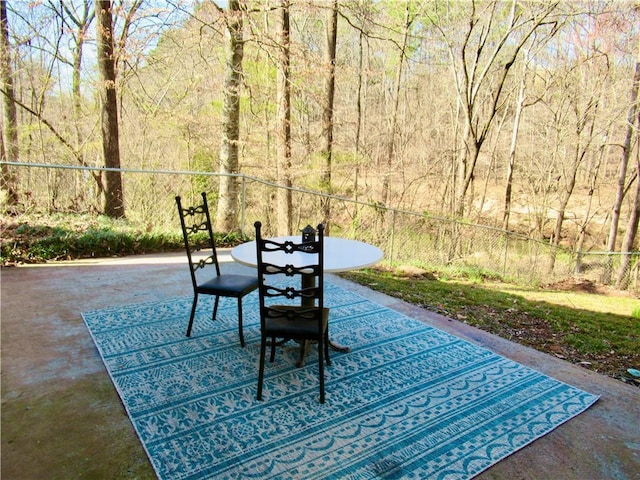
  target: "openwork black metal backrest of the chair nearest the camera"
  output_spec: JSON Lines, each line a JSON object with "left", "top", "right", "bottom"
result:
{"left": 255, "top": 222, "right": 324, "bottom": 322}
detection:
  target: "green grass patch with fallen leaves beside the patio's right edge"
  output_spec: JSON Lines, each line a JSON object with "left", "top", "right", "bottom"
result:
{"left": 344, "top": 269, "right": 640, "bottom": 378}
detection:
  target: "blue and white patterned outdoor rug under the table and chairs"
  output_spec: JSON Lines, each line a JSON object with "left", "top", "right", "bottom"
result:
{"left": 82, "top": 284, "right": 597, "bottom": 480}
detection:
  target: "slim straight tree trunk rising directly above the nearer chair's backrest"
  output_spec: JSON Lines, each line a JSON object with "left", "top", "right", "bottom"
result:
{"left": 276, "top": 0, "right": 293, "bottom": 235}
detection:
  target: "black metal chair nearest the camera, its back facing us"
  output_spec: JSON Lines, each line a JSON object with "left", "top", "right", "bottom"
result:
{"left": 255, "top": 222, "right": 331, "bottom": 403}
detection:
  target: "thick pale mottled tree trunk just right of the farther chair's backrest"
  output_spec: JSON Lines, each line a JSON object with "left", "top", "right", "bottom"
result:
{"left": 216, "top": 0, "right": 244, "bottom": 232}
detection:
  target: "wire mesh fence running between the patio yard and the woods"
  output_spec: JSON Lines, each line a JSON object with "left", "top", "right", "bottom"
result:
{"left": 2, "top": 162, "right": 640, "bottom": 293}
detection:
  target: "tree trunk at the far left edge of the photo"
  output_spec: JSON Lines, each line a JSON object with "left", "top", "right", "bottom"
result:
{"left": 0, "top": 2, "right": 20, "bottom": 211}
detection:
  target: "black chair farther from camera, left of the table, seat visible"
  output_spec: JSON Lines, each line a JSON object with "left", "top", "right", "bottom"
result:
{"left": 176, "top": 192, "right": 258, "bottom": 347}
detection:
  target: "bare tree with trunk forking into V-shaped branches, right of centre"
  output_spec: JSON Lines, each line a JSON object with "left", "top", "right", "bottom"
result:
{"left": 434, "top": 1, "right": 558, "bottom": 217}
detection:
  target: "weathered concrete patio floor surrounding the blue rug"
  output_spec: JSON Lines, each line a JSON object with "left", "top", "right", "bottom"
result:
{"left": 0, "top": 251, "right": 640, "bottom": 480}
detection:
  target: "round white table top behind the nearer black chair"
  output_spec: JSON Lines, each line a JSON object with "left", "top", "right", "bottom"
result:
{"left": 231, "top": 235, "right": 384, "bottom": 272}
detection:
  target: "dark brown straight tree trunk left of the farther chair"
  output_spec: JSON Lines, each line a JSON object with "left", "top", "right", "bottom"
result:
{"left": 95, "top": 0, "right": 125, "bottom": 218}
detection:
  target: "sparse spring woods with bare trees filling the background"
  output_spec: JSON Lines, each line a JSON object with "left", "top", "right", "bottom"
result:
{"left": 1, "top": 0, "right": 640, "bottom": 285}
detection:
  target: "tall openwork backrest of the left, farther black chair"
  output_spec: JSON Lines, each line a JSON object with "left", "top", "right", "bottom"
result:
{"left": 176, "top": 192, "right": 220, "bottom": 286}
